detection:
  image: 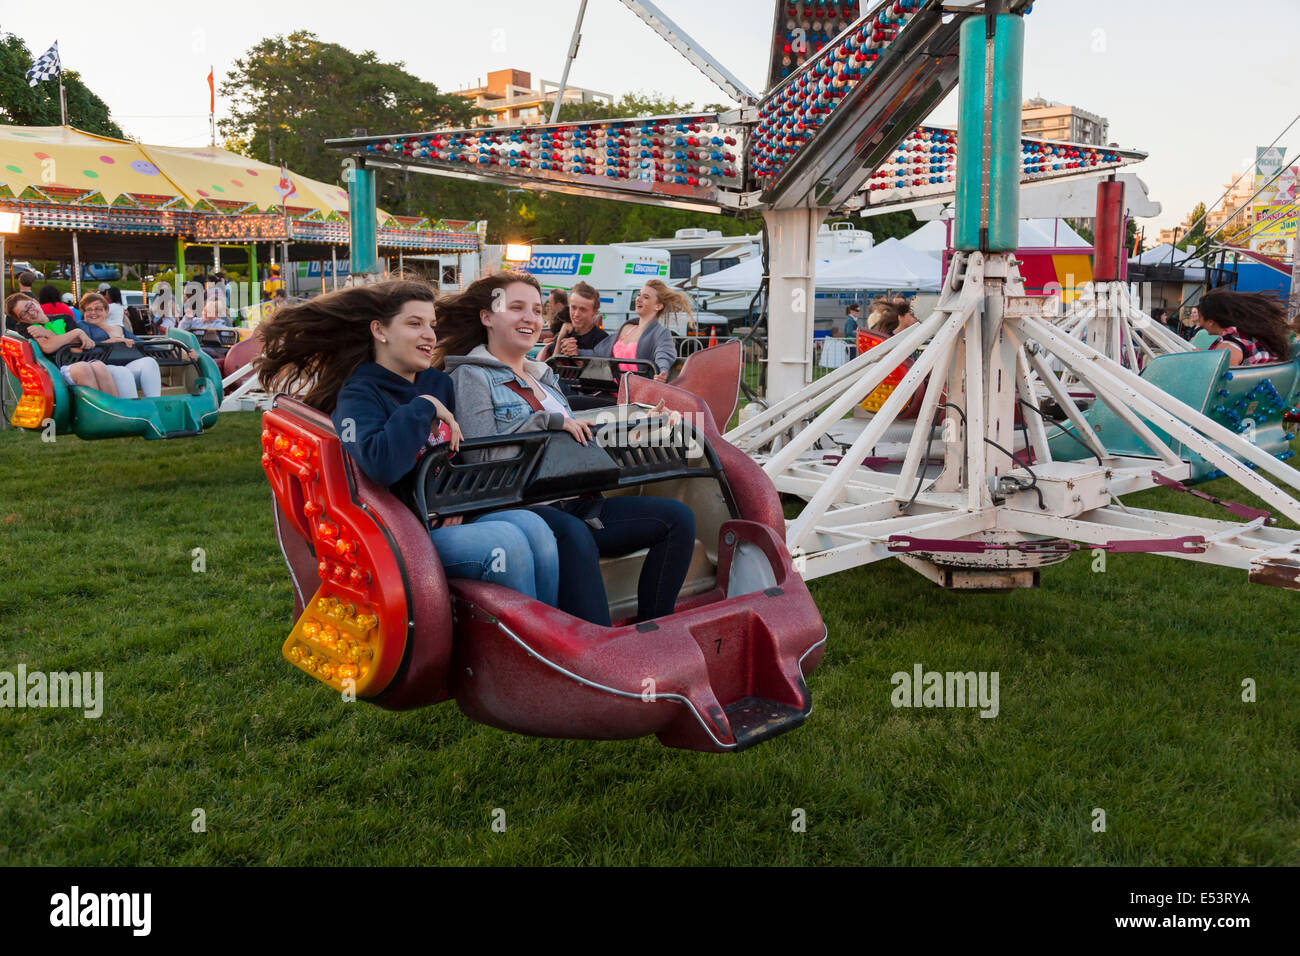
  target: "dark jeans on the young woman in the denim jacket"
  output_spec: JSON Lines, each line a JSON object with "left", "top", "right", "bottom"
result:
{"left": 533, "top": 497, "right": 696, "bottom": 627}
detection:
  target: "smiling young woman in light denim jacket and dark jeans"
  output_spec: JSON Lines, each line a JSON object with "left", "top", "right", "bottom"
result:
{"left": 438, "top": 272, "right": 696, "bottom": 627}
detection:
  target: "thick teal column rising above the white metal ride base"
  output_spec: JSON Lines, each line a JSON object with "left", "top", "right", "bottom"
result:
{"left": 953, "top": 14, "right": 1024, "bottom": 252}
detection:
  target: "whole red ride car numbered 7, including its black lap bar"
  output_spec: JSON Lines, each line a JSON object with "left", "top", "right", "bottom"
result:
{"left": 263, "top": 348, "right": 826, "bottom": 752}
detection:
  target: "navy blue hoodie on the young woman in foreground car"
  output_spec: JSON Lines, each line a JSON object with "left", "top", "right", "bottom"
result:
{"left": 332, "top": 362, "right": 456, "bottom": 501}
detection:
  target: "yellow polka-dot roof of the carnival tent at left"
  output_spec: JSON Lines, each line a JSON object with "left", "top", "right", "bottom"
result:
{"left": 0, "top": 126, "right": 356, "bottom": 220}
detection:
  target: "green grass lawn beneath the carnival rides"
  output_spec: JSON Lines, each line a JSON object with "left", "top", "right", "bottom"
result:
{"left": 0, "top": 415, "right": 1300, "bottom": 865}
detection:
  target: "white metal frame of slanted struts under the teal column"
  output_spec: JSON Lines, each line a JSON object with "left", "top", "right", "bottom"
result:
{"left": 725, "top": 238, "right": 1300, "bottom": 587}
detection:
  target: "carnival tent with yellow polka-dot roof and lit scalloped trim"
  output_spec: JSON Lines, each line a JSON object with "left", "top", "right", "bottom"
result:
{"left": 0, "top": 125, "right": 485, "bottom": 267}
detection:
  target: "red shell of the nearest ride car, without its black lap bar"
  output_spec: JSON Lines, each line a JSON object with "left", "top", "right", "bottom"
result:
{"left": 263, "top": 385, "right": 826, "bottom": 752}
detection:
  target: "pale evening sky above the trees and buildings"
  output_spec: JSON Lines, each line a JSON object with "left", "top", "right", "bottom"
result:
{"left": 0, "top": 0, "right": 1300, "bottom": 233}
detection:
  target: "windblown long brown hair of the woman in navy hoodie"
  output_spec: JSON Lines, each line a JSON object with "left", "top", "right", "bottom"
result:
{"left": 257, "top": 278, "right": 436, "bottom": 415}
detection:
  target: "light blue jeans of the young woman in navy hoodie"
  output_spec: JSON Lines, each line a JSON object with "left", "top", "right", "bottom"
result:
{"left": 429, "top": 511, "right": 559, "bottom": 607}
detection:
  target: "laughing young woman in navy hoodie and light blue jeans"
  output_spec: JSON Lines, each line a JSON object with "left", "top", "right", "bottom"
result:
{"left": 257, "top": 280, "right": 559, "bottom": 607}
